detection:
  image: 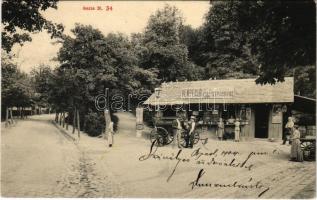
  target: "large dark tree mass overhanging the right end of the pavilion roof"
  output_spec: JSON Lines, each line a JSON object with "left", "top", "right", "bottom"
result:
{"left": 204, "top": 0, "right": 316, "bottom": 83}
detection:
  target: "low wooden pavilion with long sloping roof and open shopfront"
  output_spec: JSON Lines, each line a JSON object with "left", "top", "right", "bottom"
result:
{"left": 144, "top": 77, "right": 294, "bottom": 139}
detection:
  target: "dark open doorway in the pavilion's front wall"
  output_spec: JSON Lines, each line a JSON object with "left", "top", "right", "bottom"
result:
{"left": 254, "top": 104, "right": 270, "bottom": 138}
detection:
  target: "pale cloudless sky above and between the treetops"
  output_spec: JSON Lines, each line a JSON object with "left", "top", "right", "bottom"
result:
{"left": 9, "top": 1, "right": 210, "bottom": 73}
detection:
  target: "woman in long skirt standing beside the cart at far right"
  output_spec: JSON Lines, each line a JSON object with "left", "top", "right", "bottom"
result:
{"left": 290, "top": 125, "right": 304, "bottom": 162}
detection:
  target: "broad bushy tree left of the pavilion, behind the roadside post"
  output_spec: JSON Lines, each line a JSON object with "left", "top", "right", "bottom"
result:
{"left": 58, "top": 24, "right": 156, "bottom": 135}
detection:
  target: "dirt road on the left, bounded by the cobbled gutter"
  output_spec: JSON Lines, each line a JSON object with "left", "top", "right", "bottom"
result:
{"left": 1, "top": 115, "right": 118, "bottom": 197}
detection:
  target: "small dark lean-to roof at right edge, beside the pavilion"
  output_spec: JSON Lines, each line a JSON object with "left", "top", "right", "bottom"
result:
{"left": 292, "top": 95, "right": 316, "bottom": 114}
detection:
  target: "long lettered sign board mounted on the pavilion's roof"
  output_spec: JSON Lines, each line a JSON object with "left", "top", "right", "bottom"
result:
{"left": 181, "top": 88, "right": 234, "bottom": 99}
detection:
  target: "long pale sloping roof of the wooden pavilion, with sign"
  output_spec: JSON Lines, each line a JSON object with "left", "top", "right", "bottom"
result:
{"left": 144, "top": 77, "right": 294, "bottom": 105}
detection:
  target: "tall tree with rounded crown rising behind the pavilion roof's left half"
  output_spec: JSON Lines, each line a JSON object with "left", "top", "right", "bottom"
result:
{"left": 139, "top": 5, "right": 201, "bottom": 81}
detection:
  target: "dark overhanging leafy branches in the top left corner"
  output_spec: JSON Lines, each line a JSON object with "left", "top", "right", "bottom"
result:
{"left": 2, "top": 0, "right": 64, "bottom": 52}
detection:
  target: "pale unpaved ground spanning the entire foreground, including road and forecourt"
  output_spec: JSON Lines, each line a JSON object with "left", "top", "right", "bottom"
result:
{"left": 1, "top": 113, "right": 316, "bottom": 198}
